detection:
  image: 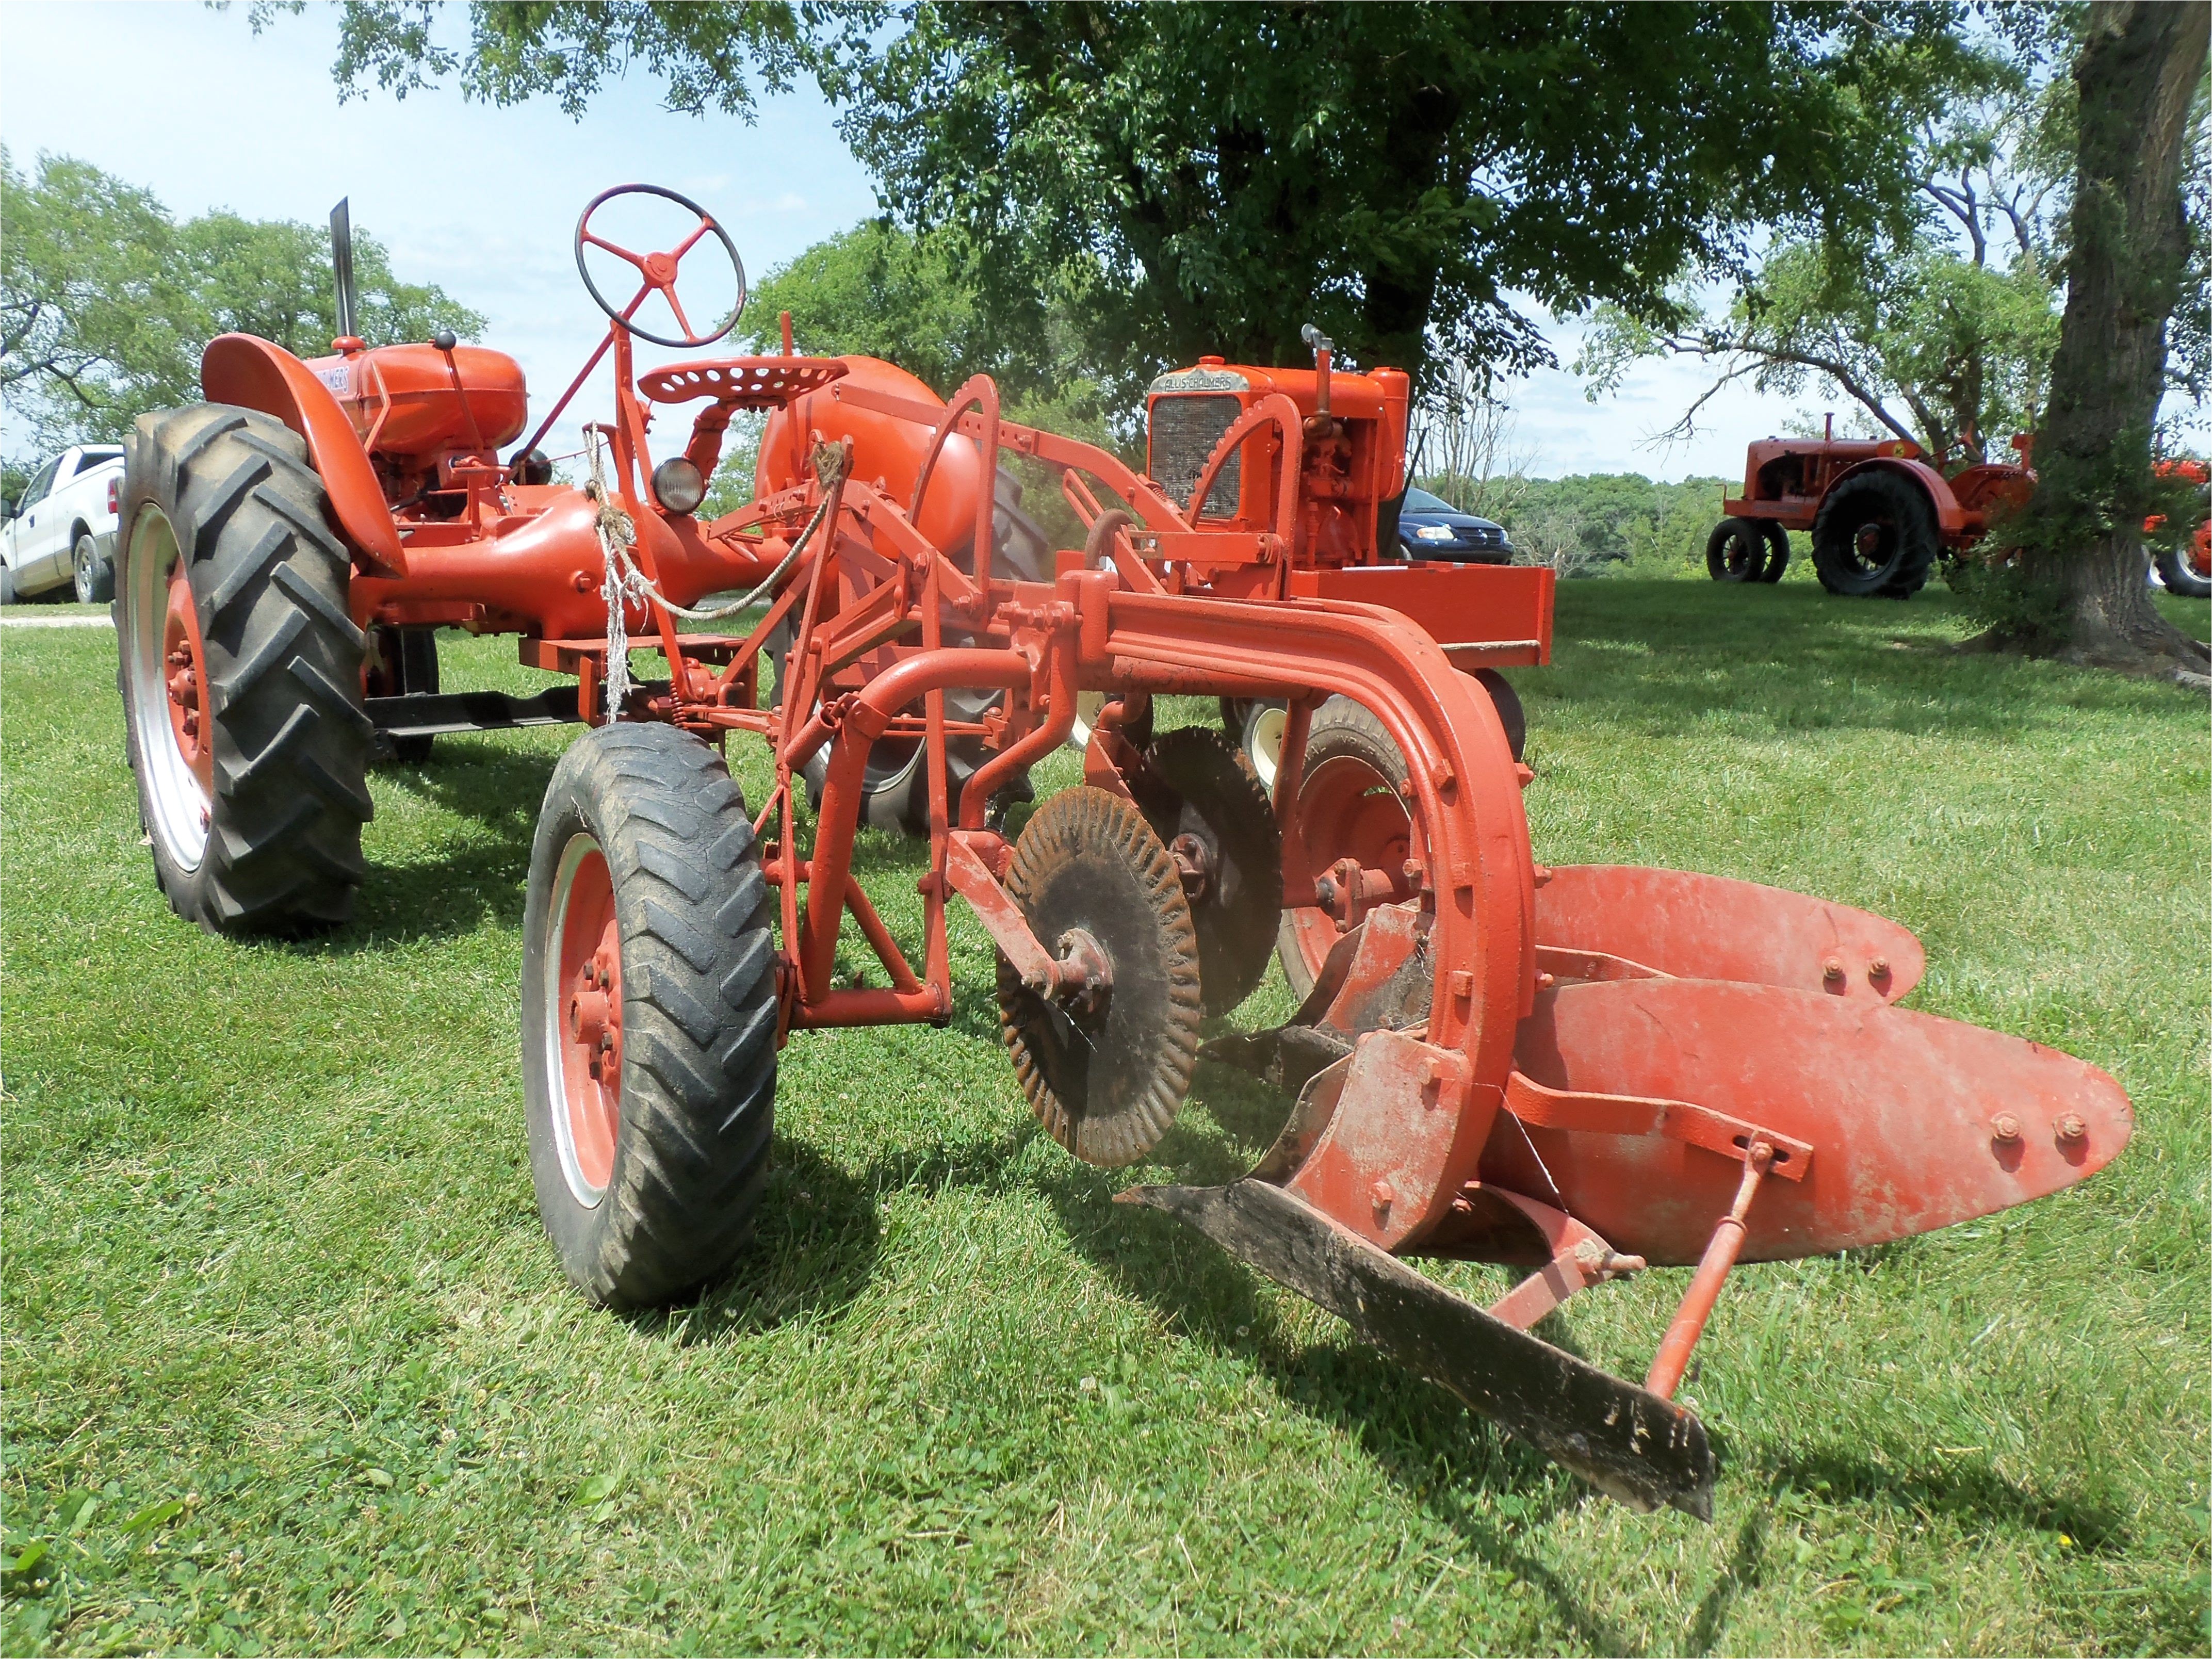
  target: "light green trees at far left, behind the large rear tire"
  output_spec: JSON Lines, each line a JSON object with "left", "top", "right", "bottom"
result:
{"left": 0, "top": 153, "right": 484, "bottom": 453}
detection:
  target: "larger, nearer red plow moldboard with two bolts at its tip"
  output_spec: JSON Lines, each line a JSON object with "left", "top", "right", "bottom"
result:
{"left": 1482, "top": 980, "right": 2135, "bottom": 1265}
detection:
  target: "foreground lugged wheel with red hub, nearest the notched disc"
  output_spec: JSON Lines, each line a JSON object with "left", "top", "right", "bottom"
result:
{"left": 522, "top": 725, "right": 776, "bottom": 1307}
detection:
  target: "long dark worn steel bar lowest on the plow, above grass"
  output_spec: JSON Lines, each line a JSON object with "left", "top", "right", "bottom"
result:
{"left": 1117, "top": 1179, "right": 1714, "bottom": 1520}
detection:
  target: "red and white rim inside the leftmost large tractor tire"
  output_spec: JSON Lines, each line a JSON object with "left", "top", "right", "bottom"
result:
{"left": 120, "top": 505, "right": 215, "bottom": 871}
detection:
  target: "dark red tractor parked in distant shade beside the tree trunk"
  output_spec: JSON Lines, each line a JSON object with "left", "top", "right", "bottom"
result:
{"left": 1705, "top": 416, "right": 2035, "bottom": 599}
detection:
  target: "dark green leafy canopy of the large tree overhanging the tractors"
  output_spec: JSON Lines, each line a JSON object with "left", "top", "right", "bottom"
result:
{"left": 294, "top": 0, "right": 1953, "bottom": 392}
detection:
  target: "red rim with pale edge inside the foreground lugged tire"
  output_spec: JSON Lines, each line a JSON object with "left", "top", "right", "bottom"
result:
{"left": 544, "top": 834, "right": 622, "bottom": 1210}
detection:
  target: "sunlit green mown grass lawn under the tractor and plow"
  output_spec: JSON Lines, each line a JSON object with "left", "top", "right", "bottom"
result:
{"left": 0, "top": 579, "right": 2212, "bottom": 1654}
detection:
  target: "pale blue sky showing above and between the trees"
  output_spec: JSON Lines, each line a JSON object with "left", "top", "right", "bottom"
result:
{"left": 0, "top": 0, "right": 1810, "bottom": 478}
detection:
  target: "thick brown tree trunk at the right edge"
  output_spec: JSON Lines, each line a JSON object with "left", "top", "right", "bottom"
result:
{"left": 2009, "top": 0, "right": 2212, "bottom": 675}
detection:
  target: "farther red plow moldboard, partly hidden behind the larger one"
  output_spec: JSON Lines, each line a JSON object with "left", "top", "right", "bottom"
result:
{"left": 1535, "top": 865, "right": 1927, "bottom": 1002}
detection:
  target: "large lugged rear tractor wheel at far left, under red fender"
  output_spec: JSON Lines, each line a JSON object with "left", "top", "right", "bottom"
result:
{"left": 115, "top": 402, "right": 374, "bottom": 934}
